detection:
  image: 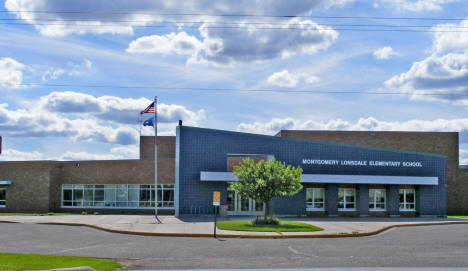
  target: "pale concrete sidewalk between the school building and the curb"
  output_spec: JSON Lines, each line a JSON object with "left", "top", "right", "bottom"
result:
{"left": 0, "top": 215, "right": 468, "bottom": 238}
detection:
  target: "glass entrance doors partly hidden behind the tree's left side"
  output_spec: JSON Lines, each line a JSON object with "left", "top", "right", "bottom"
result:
{"left": 227, "top": 190, "right": 265, "bottom": 215}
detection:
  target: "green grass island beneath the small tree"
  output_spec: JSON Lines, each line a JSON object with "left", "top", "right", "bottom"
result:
{"left": 216, "top": 220, "right": 323, "bottom": 232}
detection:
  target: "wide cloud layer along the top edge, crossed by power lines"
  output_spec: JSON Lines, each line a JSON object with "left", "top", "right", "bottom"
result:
{"left": 5, "top": 0, "right": 344, "bottom": 36}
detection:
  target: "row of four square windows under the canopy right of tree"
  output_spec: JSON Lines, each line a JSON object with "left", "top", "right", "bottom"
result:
{"left": 306, "top": 188, "right": 416, "bottom": 211}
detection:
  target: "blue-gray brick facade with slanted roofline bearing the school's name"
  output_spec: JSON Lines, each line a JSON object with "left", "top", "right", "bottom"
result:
{"left": 176, "top": 126, "right": 447, "bottom": 218}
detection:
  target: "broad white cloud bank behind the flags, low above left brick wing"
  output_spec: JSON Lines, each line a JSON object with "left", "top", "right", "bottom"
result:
{"left": 0, "top": 92, "right": 205, "bottom": 148}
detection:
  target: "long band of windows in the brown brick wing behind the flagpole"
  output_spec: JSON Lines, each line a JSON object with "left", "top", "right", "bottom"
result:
{"left": 62, "top": 184, "right": 174, "bottom": 209}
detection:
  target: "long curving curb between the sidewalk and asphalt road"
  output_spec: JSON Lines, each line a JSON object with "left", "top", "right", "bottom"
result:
{"left": 0, "top": 220, "right": 468, "bottom": 239}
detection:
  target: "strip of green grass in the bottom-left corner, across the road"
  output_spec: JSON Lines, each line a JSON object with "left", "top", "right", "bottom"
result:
{"left": 0, "top": 253, "right": 122, "bottom": 271}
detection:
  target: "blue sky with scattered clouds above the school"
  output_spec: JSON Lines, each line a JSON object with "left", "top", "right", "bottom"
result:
{"left": 0, "top": 0, "right": 468, "bottom": 164}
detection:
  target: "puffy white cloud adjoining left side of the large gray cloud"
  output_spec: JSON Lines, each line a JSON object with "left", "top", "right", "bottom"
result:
{"left": 127, "top": 32, "right": 202, "bottom": 55}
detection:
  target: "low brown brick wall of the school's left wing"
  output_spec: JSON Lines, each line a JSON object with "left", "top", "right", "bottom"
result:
{"left": 0, "top": 159, "right": 175, "bottom": 213}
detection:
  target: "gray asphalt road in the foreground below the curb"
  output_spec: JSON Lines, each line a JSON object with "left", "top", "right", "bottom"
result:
{"left": 0, "top": 223, "right": 468, "bottom": 269}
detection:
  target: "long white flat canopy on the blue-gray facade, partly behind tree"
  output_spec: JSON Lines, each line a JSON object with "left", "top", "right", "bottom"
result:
{"left": 200, "top": 171, "right": 439, "bottom": 185}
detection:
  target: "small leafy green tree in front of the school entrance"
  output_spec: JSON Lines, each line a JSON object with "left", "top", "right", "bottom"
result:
{"left": 231, "top": 159, "right": 302, "bottom": 221}
